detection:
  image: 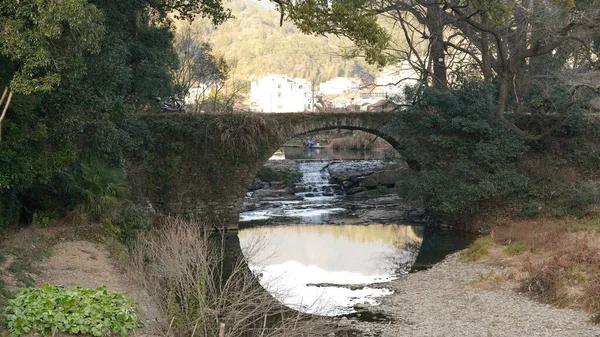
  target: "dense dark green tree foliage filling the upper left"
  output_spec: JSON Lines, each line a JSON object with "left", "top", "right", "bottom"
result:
{"left": 0, "top": 0, "right": 230, "bottom": 226}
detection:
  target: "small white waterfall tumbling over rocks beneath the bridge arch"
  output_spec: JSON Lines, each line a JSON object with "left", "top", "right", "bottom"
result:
{"left": 296, "top": 161, "right": 342, "bottom": 199}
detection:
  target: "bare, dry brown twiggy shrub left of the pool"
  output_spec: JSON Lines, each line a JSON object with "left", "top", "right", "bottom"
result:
{"left": 131, "top": 219, "right": 332, "bottom": 337}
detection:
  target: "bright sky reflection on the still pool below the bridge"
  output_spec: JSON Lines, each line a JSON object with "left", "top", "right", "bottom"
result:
{"left": 239, "top": 225, "right": 422, "bottom": 315}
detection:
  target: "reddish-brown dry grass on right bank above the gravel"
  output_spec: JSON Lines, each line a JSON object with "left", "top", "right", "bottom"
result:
{"left": 461, "top": 218, "right": 600, "bottom": 323}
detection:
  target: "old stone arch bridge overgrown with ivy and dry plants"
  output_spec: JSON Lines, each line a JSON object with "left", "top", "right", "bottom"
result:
{"left": 134, "top": 112, "right": 400, "bottom": 230}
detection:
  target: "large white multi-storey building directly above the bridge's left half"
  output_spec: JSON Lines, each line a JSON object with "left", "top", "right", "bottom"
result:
{"left": 250, "top": 74, "right": 314, "bottom": 112}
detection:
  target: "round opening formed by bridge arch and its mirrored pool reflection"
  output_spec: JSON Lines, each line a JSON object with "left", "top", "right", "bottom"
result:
{"left": 238, "top": 125, "right": 423, "bottom": 315}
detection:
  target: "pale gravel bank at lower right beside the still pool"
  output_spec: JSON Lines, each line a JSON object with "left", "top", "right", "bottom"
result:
{"left": 352, "top": 254, "right": 600, "bottom": 337}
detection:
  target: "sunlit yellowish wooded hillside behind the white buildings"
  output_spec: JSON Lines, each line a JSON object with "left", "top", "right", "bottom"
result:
{"left": 177, "top": 0, "right": 377, "bottom": 84}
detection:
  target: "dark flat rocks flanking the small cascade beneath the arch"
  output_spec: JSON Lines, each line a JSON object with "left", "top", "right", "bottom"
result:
{"left": 242, "top": 160, "right": 423, "bottom": 224}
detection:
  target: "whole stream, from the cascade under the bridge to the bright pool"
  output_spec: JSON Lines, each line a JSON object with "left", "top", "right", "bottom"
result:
{"left": 239, "top": 149, "right": 471, "bottom": 316}
